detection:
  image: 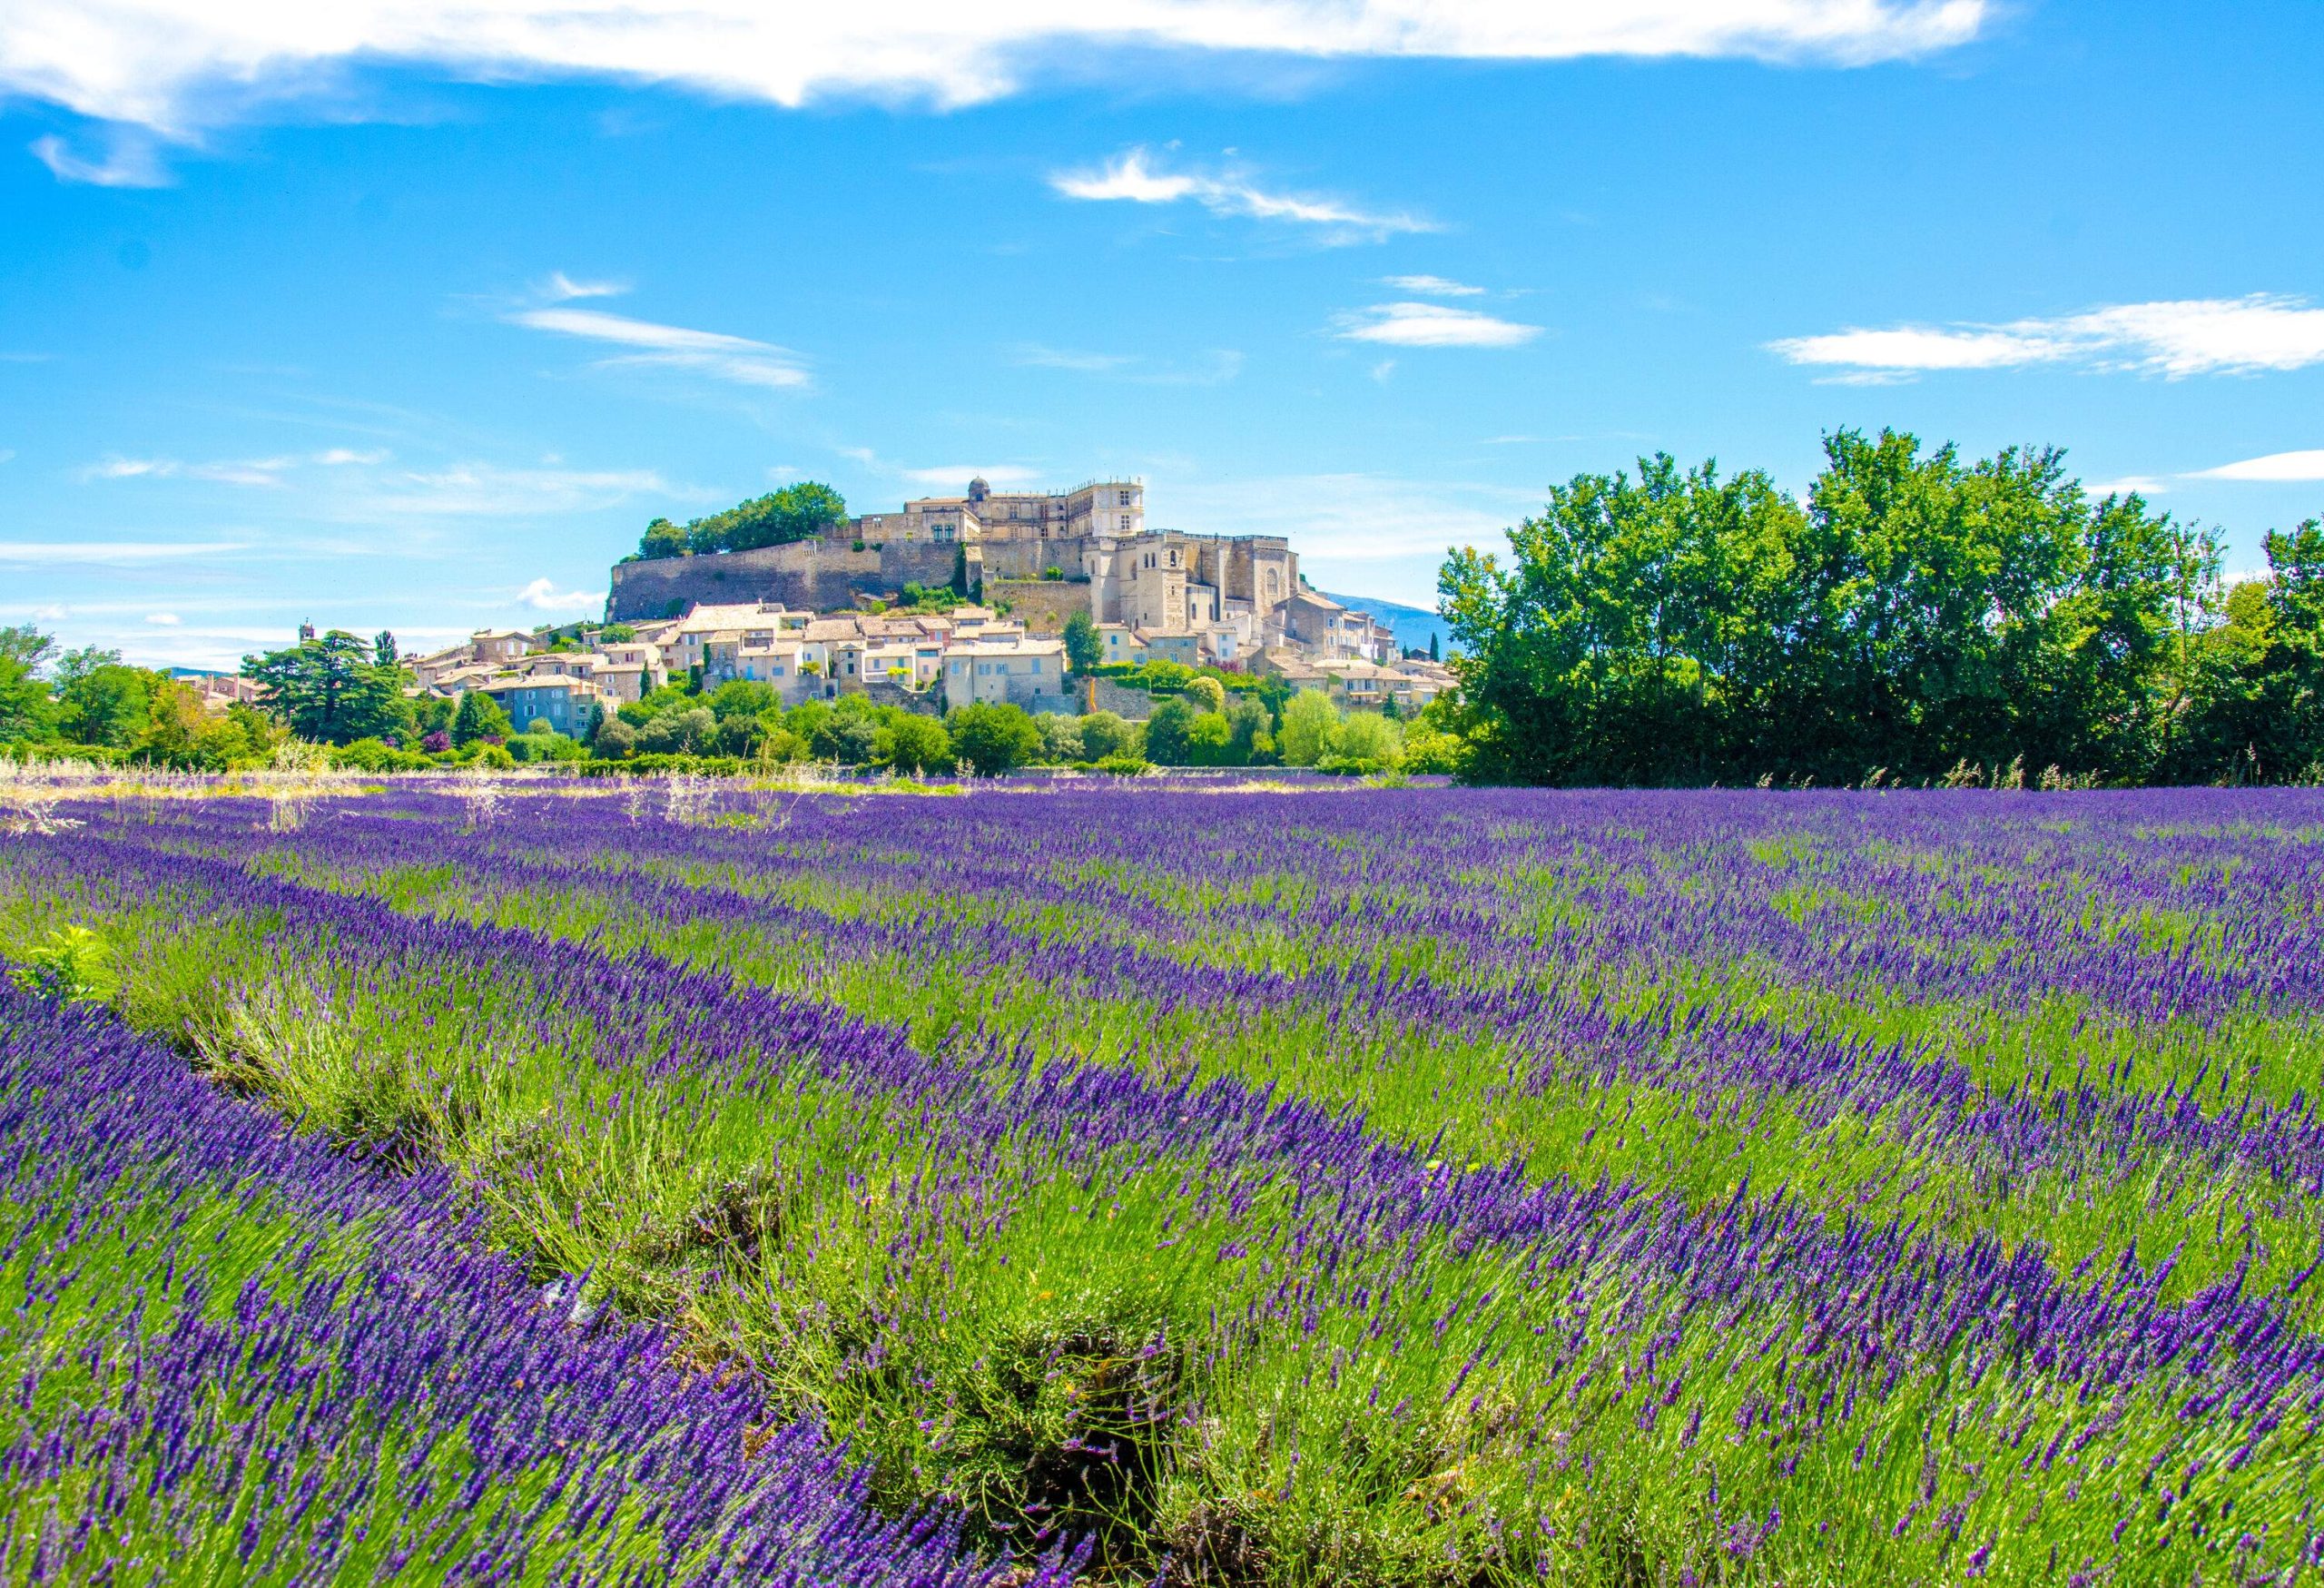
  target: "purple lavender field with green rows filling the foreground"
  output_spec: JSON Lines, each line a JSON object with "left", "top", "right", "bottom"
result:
{"left": 0, "top": 779, "right": 2324, "bottom": 1588}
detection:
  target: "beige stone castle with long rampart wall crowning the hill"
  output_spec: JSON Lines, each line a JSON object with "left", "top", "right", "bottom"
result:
{"left": 606, "top": 479, "right": 1315, "bottom": 646}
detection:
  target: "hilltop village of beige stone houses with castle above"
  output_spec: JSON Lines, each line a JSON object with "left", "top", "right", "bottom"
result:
{"left": 407, "top": 479, "right": 1452, "bottom": 739}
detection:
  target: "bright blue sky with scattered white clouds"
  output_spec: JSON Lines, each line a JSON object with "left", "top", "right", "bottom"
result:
{"left": 0, "top": 0, "right": 2324, "bottom": 663}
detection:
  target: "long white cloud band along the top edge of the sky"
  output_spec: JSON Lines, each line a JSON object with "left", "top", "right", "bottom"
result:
{"left": 0, "top": 0, "right": 1994, "bottom": 135}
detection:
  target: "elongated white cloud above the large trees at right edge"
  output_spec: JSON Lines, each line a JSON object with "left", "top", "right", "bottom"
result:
{"left": 1768, "top": 293, "right": 2324, "bottom": 381}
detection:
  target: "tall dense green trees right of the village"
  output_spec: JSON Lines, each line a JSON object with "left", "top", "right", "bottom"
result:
{"left": 1439, "top": 430, "right": 2324, "bottom": 786}
